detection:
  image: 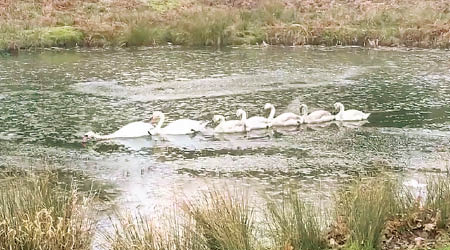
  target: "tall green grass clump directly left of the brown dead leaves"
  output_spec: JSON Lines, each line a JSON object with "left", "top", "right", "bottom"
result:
{"left": 336, "top": 177, "right": 409, "bottom": 250}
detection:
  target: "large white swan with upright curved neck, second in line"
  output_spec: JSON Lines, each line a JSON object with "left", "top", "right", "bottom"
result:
{"left": 148, "top": 111, "right": 208, "bottom": 135}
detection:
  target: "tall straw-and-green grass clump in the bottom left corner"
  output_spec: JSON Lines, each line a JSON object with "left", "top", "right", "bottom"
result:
{"left": 0, "top": 169, "right": 93, "bottom": 249}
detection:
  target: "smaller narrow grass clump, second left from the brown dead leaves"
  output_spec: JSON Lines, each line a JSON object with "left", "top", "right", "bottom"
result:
{"left": 268, "top": 191, "right": 327, "bottom": 249}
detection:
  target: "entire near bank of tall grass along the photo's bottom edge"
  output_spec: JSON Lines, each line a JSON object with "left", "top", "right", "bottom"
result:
{"left": 0, "top": 166, "right": 450, "bottom": 250}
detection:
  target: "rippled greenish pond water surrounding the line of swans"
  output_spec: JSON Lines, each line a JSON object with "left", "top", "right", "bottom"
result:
{"left": 0, "top": 47, "right": 450, "bottom": 214}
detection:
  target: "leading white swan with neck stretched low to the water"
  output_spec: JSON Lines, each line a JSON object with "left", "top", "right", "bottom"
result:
{"left": 83, "top": 121, "right": 153, "bottom": 142}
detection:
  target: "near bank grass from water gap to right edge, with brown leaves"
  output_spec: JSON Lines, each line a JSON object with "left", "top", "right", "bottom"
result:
{"left": 108, "top": 177, "right": 450, "bottom": 250}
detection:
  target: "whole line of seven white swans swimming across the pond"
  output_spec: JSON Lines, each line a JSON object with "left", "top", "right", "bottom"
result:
{"left": 83, "top": 102, "right": 370, "bottom": 142}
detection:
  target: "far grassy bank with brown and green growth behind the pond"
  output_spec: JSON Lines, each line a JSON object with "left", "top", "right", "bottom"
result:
{"left": 0, "top": 0, "right": 450, "bottom": 51}
